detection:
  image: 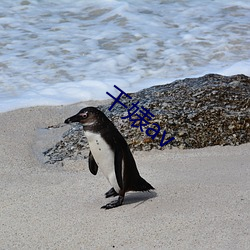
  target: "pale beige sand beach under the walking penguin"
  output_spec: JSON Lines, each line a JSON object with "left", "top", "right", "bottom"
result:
{"left": 0, "top": 100, "right": 250, "bottom": 250}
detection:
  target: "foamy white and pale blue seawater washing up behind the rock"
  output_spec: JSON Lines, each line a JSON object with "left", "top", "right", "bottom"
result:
{"left": 0, "top": 0, "right": 250, "bottom": 112}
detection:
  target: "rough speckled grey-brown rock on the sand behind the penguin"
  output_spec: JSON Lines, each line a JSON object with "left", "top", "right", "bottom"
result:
{"left": 44, "top": 74, "right": 250, "bottom": 163}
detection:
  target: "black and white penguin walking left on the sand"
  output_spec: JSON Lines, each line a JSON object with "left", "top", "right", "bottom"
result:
{"left": 65, "top": 107, "right": 154, "bottom": 209}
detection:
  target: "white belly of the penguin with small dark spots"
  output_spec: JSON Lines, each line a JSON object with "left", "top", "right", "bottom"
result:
{"left": 85, "top": 131, "right": 120, "bottom": 193}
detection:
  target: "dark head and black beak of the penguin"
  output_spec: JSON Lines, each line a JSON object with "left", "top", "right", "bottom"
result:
{"left": 64, "top": 107, "right": 108, "bottom": 129}
